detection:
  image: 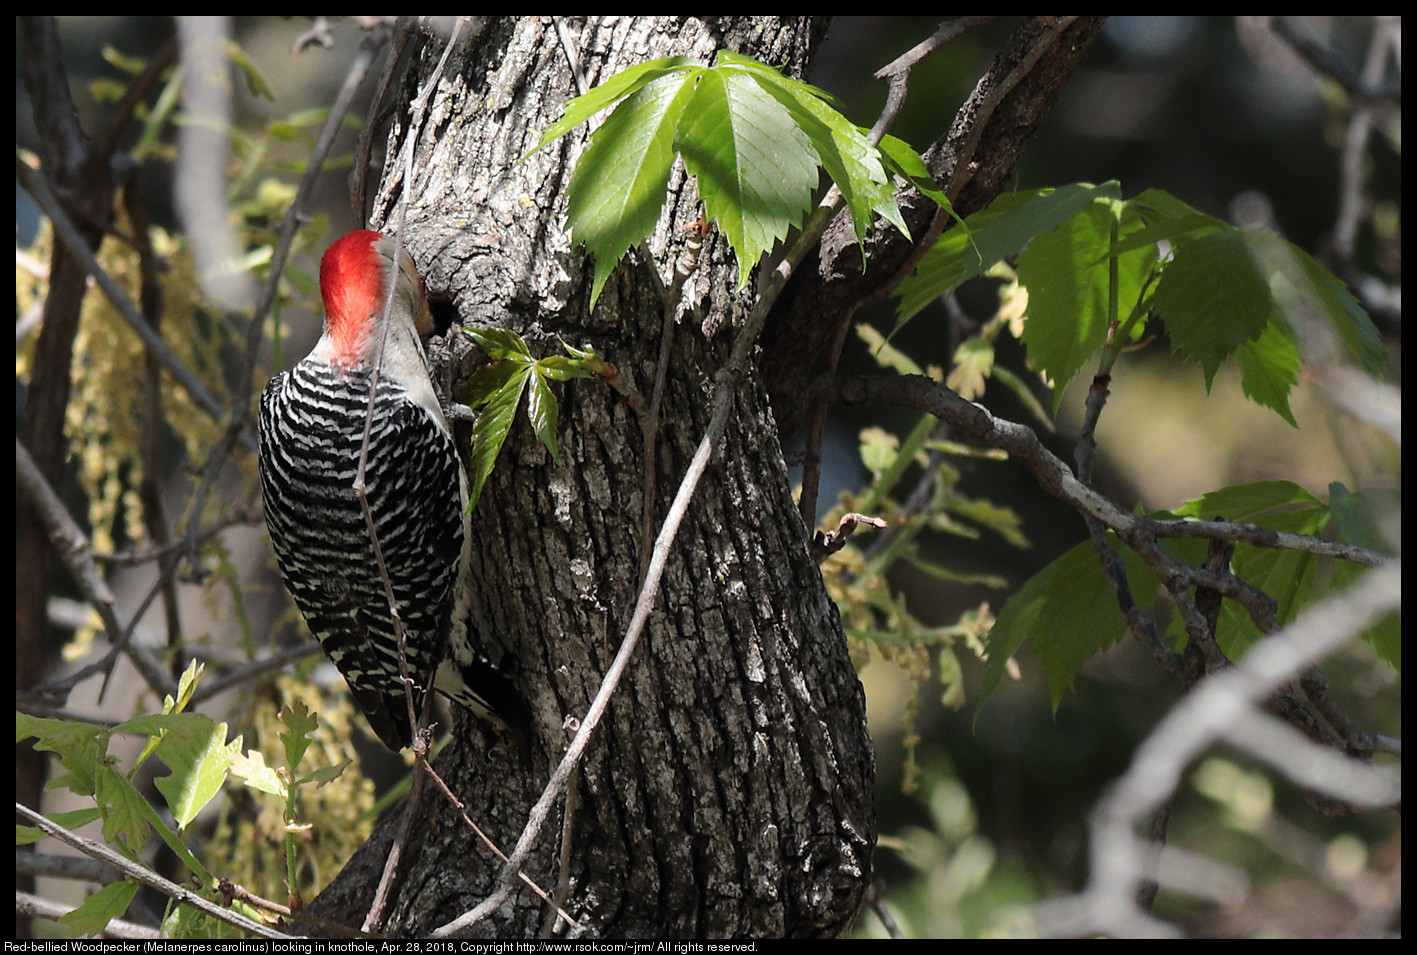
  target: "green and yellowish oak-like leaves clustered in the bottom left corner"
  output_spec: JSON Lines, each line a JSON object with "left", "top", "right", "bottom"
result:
{"left": 14, "top": 660, "right": 344, "bottom": 938}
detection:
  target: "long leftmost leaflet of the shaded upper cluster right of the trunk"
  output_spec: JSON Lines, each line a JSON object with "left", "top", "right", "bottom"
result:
{"left": 893, "top": 181, "right": 1119, "bottom": 334}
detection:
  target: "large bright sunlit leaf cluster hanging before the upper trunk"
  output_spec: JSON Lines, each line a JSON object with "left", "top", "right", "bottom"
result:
{"left": 529, "top": 50, "right": 948, "bottom": 305}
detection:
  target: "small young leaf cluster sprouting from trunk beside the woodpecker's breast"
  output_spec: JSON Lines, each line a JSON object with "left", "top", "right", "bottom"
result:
{"left": 468, "top": 329, "right": 611, "bottom": 509}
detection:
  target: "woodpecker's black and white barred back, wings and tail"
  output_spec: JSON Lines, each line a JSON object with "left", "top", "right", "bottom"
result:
{"left": 258, "top": 358, "right": 524, "bottom": 751}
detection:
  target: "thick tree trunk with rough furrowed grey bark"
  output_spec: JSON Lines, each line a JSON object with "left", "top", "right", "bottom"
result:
{"left": 316, "top": 17, "right": 876, "bottom": 938}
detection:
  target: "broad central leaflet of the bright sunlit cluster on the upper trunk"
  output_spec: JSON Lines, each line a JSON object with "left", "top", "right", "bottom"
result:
{"left": 676, "top": 71, "right": 818, "bottom": 288}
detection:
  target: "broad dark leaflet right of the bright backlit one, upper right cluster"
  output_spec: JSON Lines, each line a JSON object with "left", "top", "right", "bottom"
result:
{"left": 1150, "top": 231, "right": 1274, "bottom": 388}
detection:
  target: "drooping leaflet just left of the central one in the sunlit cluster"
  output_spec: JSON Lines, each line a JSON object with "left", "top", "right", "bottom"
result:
{"left": 567, "top": 71, "right": 706, "bottom": 307}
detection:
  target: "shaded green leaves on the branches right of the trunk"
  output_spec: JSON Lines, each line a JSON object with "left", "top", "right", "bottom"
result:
{"left": 896, "top": 183, "right": 1400, "bottom": 707}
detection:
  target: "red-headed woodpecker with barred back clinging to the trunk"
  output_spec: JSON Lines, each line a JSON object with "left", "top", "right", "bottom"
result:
{"left": 258, "top": 231, "right": 526, "bottom": 751}
